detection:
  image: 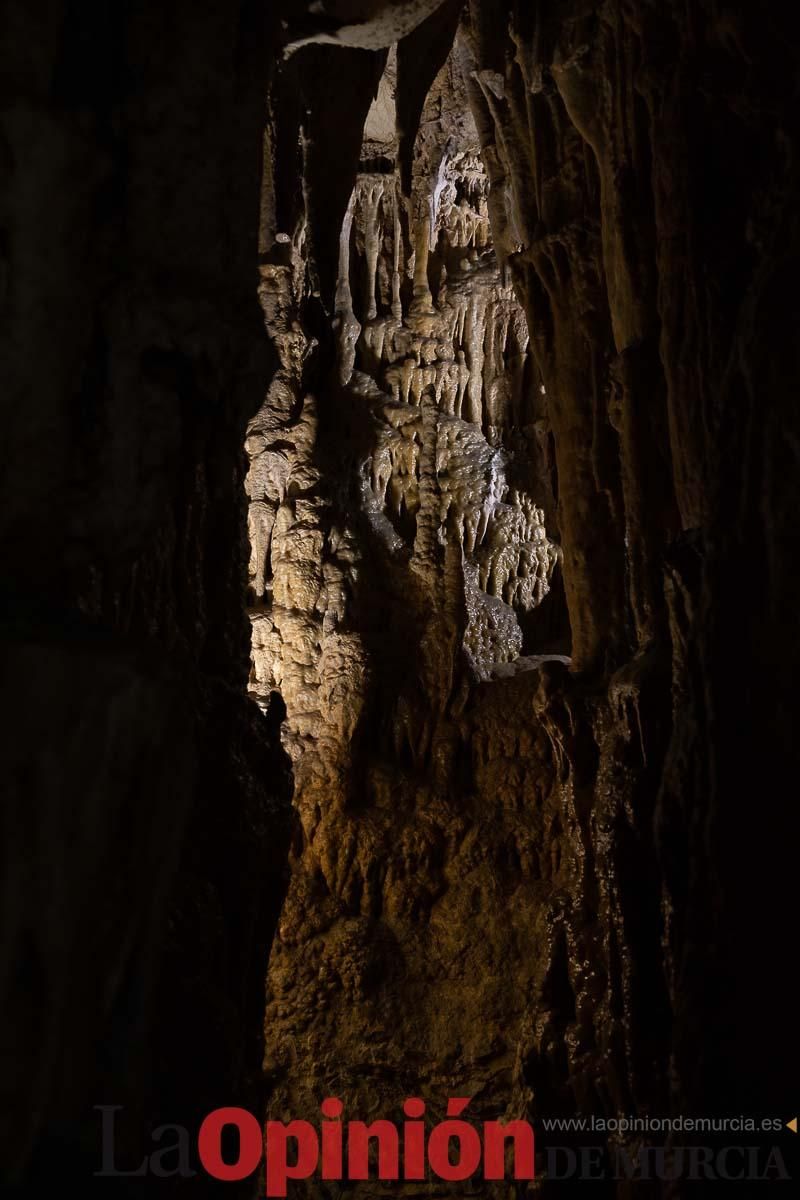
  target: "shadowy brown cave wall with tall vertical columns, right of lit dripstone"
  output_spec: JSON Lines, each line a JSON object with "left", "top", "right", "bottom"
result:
{"left": 462, "top": 2, "right": 799, "bottom": 1132}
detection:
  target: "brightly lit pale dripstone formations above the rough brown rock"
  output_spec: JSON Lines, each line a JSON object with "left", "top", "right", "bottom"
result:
{"left": 247, "top": 51, "right": 560, "bottom": 763}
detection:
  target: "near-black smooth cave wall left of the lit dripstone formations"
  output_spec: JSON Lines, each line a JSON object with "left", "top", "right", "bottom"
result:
{"left": 0, "top": 0, "right": 291, "bottom": 1193}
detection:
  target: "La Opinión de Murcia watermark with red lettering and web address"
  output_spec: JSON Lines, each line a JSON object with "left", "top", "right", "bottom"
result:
{"left": 95, "top": 1097, "right": 798, "bottom": 1198}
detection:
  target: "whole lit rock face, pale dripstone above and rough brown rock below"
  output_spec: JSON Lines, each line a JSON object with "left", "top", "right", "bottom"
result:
{"left": 247, "top": 46, "right": 569, "bottom": 1147}
